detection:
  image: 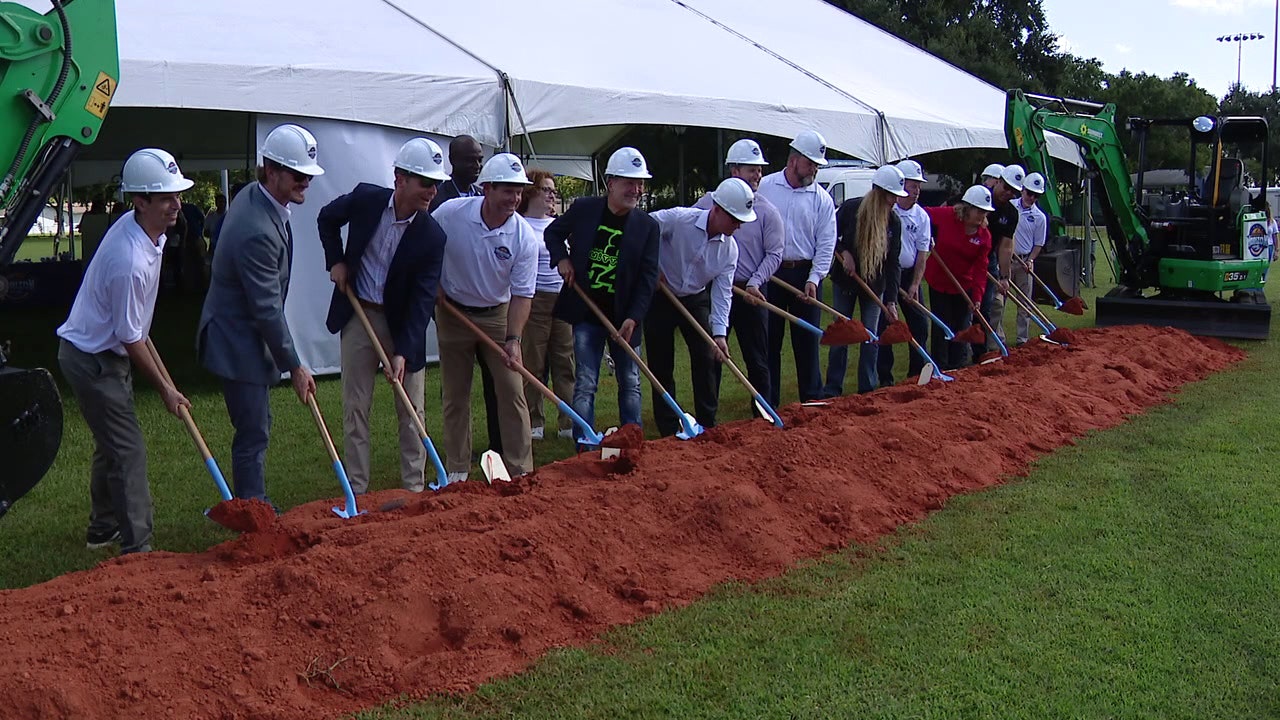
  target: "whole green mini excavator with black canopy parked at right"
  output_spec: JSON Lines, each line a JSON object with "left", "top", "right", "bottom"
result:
{"left": 1005, "top": 90, "right": 1271, "bottom": 338}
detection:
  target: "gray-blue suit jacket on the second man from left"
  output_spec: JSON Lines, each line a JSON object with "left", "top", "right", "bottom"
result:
{"left": 196, "top": 182, "right": 301, "bottom": 384}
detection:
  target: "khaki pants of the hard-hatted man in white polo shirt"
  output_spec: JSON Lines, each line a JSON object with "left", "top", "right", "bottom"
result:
{"left": 435, "top": 302, "right": 534, "bottom": 475}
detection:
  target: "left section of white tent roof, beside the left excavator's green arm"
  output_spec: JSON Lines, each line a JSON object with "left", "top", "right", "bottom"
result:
{"left": 101, "top": 0, "right": 504, "bottom": 146}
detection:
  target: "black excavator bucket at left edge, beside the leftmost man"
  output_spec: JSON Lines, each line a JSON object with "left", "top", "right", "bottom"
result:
{"left": 0, "top": 368, "right": 63, "bottom": 516}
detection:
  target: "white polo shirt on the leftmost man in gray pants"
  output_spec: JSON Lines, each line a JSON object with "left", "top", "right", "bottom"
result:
{"left": 58, "top": 210, "right": 165, "bottom": 356}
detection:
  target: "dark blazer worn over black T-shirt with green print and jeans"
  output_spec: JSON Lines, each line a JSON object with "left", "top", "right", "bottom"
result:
{"left": 543, "top": 197, "right": 660, "bottom": 330}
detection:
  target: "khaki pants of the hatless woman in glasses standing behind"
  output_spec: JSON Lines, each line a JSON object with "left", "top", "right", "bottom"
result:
{"left": 520, "top": 292, "right": 573, "bottom": 430}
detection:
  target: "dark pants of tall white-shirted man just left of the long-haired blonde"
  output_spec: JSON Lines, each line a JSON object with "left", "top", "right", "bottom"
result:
{"left": 764, "top": 263, "right": 822, "bottom": 407}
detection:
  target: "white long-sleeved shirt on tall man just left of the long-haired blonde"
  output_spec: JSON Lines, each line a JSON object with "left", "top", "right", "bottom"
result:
{"left": 756, "top": 172, "right": 836, "bottom": 284}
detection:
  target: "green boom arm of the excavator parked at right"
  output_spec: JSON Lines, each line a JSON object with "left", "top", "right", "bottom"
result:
{"left": 1005, "top": 90, "right": 1156, "bottom": 288}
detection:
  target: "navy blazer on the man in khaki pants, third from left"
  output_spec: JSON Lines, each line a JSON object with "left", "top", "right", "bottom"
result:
{"left": 316, "top": 182, "right": 445, "bottom": 373}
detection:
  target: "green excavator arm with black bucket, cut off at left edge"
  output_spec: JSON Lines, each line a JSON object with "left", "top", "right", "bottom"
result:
{"left": 0, "top": 0, "right": 120, "bottom": 516}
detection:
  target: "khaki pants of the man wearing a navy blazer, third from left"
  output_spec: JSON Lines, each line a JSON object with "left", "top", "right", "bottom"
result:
{"left": 342, "top": 306, "right": 426, "bottom": 493}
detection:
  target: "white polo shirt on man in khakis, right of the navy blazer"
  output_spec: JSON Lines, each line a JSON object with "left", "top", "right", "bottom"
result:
{"left": 431, "top": 197, "right": 538, "bottom": 307}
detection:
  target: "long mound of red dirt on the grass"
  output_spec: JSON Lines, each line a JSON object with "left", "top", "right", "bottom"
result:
{"left": 0, "top": 327, "right": 1244, "bottom": 720}
